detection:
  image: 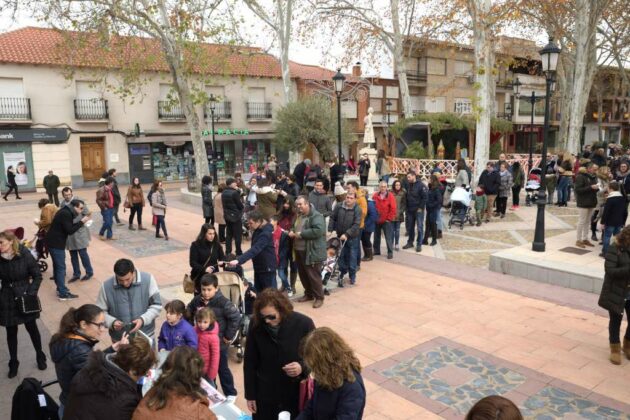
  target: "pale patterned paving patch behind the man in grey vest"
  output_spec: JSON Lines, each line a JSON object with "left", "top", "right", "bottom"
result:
{"left": 90, "top": 210, "right": 190, "bottom": 257}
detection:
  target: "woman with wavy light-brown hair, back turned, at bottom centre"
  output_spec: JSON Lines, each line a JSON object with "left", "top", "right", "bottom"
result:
{"left": 298, "top": 327, "right": 366, "bottom": 420}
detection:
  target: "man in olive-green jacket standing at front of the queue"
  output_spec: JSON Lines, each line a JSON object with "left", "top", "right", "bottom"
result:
{"left": 289, "top": 195, "right": 326, "bottom": 308}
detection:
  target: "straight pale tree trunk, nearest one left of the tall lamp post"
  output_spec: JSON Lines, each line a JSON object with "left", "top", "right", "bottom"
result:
{"left": 469, "top": 0, "right": 496, "bottom": 178}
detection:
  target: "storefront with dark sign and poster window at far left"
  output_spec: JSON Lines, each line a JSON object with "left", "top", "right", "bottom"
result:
{"left": 0, "top": 128, "right": 69, "bottom": 191}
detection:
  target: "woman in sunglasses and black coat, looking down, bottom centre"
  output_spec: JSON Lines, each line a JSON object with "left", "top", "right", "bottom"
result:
{"left": 243, "top": 288, "right": 315, "bottom": 420}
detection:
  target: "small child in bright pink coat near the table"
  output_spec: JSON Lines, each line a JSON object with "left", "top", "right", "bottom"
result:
{"left": 195, "top": 308, "right": 221, "bottom": 387}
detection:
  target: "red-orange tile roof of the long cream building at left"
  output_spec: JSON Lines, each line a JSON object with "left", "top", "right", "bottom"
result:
{"left": 0, "top": 27, "right": 282, "bottom": 78}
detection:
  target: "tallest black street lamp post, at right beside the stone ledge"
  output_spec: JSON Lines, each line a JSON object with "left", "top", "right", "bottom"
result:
{"left": 532, "top": 38, "right": 561, "bottom": 252}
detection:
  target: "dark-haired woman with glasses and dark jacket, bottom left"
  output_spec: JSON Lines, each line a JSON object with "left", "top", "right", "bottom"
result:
{"left": 49, "top": 303, "right": 128, "bottom": 419}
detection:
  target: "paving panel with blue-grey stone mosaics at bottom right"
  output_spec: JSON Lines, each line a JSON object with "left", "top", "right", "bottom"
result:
{"left": 364, "top": 337, "right": 630, "bottom": 420}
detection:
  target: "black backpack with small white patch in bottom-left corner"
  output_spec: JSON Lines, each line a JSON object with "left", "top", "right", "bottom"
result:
{"left": 11, "top": 378, "right": 59, "bottom": 420}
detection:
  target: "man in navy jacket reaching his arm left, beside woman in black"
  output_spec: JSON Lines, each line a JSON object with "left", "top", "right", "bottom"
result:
{"left": 230, "top": 210, "right": 276, "bottom": 293}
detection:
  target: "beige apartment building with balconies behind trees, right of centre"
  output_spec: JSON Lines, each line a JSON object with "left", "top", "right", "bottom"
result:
{"left": 406, "top": 37, "right": 545, "bottom": 157}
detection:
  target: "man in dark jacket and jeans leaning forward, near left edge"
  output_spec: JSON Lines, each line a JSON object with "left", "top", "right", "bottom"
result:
{"left": 46, "top": 200, "right": 90, "bottom": 300}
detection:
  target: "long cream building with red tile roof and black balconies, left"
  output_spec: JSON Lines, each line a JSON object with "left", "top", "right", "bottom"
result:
{"left": 0, "top": 27, "right": 296, "bottom": 190}
